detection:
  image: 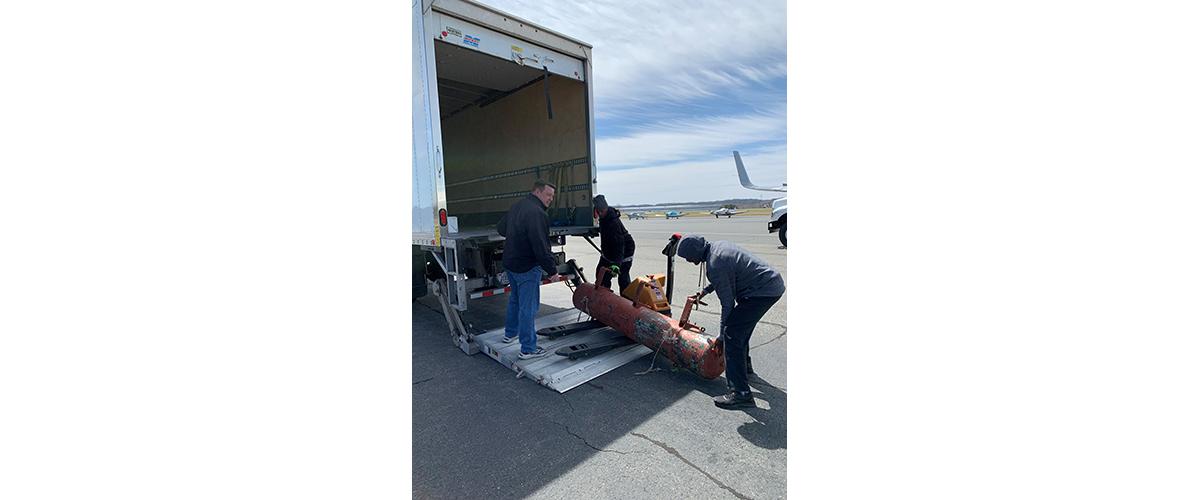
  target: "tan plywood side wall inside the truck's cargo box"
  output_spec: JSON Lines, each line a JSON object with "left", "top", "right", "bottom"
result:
{"left": 442, "top": 74, "right": 592, "bottom": 228}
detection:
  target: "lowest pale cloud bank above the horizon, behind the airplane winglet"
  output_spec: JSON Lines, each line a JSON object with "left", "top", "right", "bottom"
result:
{"left": 598, "top": 146, "right": 787, "bottom": 205}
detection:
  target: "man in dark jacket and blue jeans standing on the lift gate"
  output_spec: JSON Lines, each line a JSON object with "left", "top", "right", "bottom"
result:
{"left": 496, "top": 180, "right": 558, "bottom": 360}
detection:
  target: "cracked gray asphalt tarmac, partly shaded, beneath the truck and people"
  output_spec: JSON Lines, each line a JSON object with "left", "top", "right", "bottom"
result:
{"left": 412, "top": 217, "right": 787, "bottom": 500}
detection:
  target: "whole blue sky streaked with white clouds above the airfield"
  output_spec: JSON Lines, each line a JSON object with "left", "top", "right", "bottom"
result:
{"left": 482, "top": 0, "right": 787, "bottom": 204}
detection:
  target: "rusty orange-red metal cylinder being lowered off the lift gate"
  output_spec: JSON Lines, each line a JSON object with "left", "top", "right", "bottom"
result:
{"left": 571, "top": 283, "right": 725, "bottom": 379}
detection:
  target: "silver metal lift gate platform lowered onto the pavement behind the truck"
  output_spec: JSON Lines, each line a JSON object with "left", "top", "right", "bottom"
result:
{"left": 475, "top": 309, "right": 650, "bottom": 392}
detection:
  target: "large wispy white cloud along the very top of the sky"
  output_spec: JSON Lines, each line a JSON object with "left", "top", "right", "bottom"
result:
{"left": 484, "top": 0, "right": 787, "bottom": 110}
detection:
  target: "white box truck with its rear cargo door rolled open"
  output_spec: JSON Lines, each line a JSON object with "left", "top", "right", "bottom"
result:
{"left": 413, "top": 0, "right": 598, "bottom": 354}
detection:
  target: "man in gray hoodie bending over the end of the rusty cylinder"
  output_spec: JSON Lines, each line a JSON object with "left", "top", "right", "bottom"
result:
{"left": 676, "top": 235, "right": 786, "bottom": 409}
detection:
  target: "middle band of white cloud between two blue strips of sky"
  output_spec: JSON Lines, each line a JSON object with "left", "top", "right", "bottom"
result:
{"left": 596, "top": 109, "right": 787, "bottom": 169}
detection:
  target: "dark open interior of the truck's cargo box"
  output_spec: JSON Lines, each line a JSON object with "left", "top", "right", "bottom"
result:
{"left": 434, "top": 41, "right": 592, "bottom": 230}
